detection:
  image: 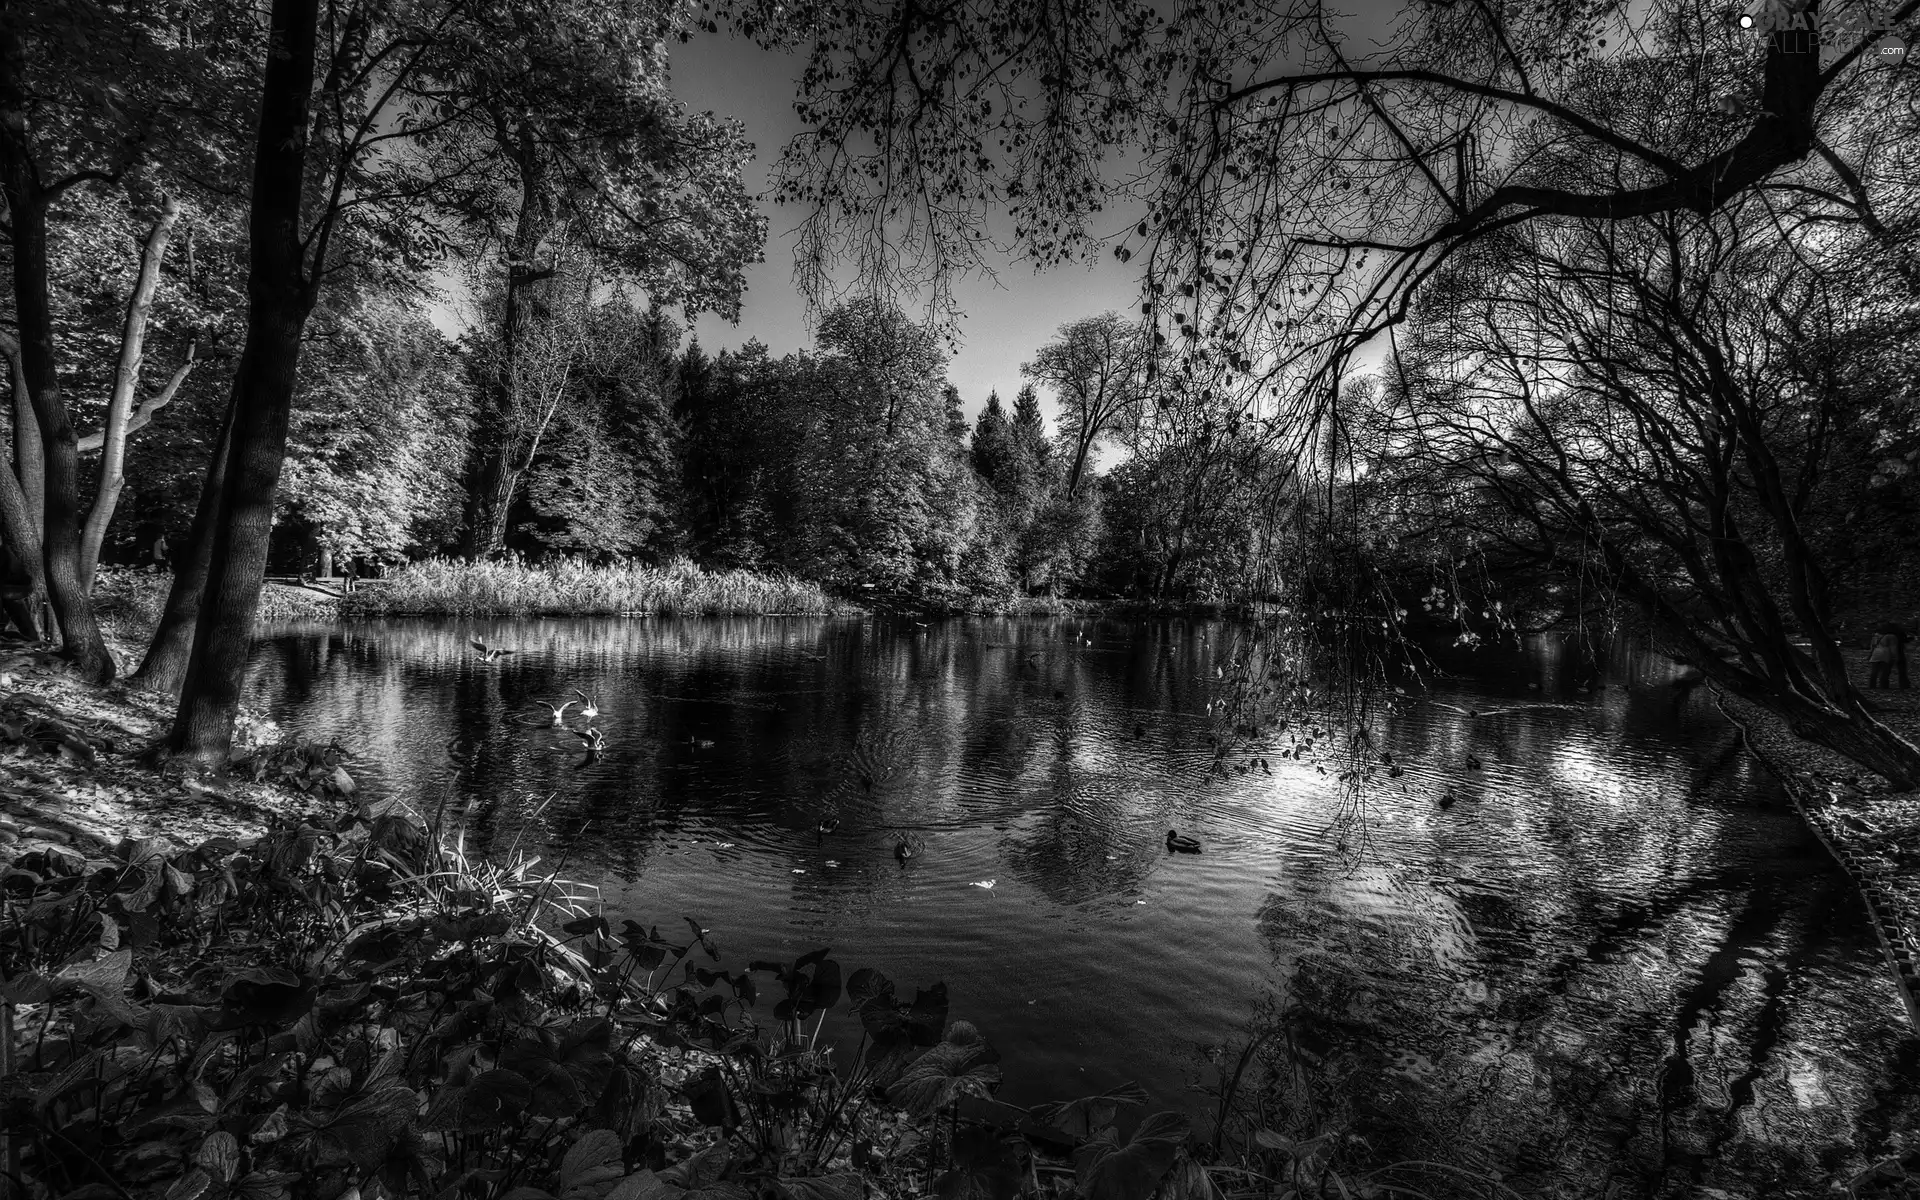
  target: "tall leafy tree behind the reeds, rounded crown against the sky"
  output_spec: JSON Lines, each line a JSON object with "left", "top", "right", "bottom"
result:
{"left": 432, "top": 0, "right": 766, "bottom": 555}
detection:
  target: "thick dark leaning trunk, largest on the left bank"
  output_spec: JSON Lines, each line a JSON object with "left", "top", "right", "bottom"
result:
{"left": 171, "top": 0, "right": 319, "bottom": 768}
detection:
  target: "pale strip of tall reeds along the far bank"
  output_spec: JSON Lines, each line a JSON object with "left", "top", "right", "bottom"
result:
{"left": 342, "top": 559, "right": 847, "bottom": 616}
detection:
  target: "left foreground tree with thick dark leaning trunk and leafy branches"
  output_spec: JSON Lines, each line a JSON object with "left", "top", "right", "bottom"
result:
{"left": 133, "top": 0, "right": 753, "bottom": 762}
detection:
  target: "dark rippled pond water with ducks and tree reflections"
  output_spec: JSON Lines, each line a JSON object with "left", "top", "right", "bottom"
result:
{"left": 250, "top": 618, "right": 1920, "bottom": 1196}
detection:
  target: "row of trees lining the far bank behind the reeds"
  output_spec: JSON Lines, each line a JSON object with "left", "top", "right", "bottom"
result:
{"left": 48, "top": 275, "right": 1261, "bottom": 605}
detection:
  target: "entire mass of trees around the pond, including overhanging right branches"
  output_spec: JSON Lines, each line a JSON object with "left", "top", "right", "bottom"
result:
{"left": 11, "top": 0, "right": 1920, "bottom": 787}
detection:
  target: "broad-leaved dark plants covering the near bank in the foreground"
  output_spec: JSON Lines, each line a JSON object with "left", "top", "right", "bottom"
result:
{"left": 0, "top": 768, "right": 1536, "bottom": 1200}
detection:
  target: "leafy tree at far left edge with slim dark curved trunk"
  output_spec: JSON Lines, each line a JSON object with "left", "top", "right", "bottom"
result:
{"left": 0, "top": 4, "right": 234, "bottom": 682}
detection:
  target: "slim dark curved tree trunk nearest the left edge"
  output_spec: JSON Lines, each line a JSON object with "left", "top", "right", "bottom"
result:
{"left": 0, "top": 42, "right": 115, "bottom": 684}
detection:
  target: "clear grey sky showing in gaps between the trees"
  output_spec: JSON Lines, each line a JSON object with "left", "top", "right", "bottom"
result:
{"left": 672, "top": 33, "right": 1139, "bottom": 417}
